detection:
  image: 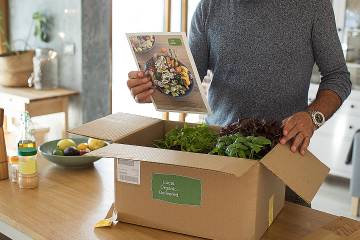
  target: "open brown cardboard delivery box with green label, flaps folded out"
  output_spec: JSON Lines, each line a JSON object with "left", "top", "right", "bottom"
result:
{"left": 71, "top": 113, "right": 329, "bottom": 240}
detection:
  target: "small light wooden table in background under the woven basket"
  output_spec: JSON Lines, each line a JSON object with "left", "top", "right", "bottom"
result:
{"left": 0, "top": 86, "right": 77, "bottom": 135}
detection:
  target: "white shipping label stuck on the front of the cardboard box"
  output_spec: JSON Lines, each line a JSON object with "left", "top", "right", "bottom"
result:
{"left": 116, "top": 158, "right": 140, "bottom": 185}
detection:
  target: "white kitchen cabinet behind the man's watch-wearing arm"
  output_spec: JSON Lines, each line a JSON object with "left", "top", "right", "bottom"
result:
{"left": 309, "top": 84, "right": 360, "bottom": 178}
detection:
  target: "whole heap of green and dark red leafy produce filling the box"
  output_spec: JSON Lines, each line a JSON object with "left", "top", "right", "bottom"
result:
{"left": 155, "top": 119, "right": 282, "bottom": 160}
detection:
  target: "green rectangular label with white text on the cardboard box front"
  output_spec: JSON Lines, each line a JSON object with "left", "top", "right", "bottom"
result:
{"left": 152, "top": 173, "right": 201, "bottom": 206}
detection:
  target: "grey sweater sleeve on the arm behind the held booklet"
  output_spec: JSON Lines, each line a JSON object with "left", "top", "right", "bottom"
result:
{"left": 189, "top": 0, "right": 209, "bottom": 80}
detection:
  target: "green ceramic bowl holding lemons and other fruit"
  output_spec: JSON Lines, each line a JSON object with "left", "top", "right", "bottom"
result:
{"left": 39, "top": 138, "right": 105, "bottom": 168}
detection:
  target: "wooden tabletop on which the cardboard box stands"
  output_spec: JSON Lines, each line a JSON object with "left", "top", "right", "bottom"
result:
{"left": 0, "top": 159, "right": 354, "bottom": 240}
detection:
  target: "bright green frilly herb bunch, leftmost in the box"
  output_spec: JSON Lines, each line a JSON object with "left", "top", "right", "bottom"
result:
{"left": 155, "top": 124, "right": 218, "bottom": 153}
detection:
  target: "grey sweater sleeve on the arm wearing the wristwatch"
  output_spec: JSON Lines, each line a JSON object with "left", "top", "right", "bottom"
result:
{"left": 311, "top": 0, "right": 351, "bottom": 102}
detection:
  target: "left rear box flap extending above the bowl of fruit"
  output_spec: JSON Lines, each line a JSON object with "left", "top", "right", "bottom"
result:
{"left": 68, "top": 113, "right": 161, "bottom": 142}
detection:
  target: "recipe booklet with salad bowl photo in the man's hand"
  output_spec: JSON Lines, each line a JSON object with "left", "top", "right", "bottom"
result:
{"left": 126, "top": 33, "right": 210, "bottom": 114}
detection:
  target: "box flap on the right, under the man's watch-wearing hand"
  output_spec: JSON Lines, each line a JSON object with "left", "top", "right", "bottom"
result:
{"left": 261, "top": 144, "right": 330, "bottom": 203}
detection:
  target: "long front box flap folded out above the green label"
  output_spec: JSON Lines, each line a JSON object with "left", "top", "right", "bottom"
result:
{"left": 86, "top": 144, "right": 258, "bottom": 177}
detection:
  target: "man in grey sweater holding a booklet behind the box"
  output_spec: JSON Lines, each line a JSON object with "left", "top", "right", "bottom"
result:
{"left": 127, "top": 0, "right": 351, "bottom": 205}
